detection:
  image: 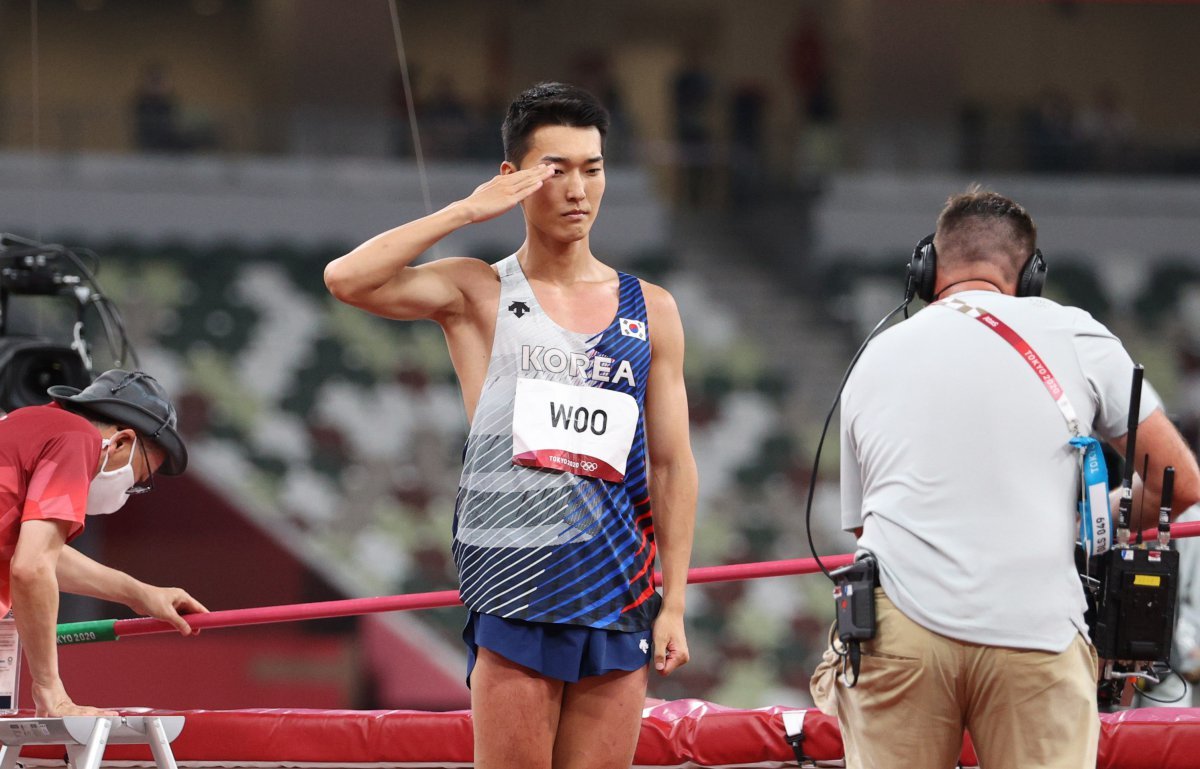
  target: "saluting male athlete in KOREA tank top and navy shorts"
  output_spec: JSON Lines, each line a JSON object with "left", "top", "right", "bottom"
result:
{"left": 325, "top": 83, "right": 696, "bottom": 769}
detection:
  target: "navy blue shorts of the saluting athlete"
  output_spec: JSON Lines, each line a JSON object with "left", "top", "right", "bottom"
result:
{"left": 462, "top": 612, "right": 654, "bottom": 686}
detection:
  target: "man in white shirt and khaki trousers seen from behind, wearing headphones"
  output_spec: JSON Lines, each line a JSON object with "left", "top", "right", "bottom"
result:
{"left": 812, "top": 187, "right": 1200, "bottom": 769}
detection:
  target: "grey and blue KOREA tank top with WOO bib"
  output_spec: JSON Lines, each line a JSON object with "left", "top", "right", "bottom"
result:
{"left": 454, "top": 256, "right": 661, "bottom": 631}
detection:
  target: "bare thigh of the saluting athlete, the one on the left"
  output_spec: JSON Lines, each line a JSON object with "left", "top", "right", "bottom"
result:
{"left": 470, "top": 647, "right": 563, "bottom": 769}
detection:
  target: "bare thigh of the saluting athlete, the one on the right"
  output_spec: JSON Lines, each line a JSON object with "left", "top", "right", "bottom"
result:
{"left": 554, "top": 667, "right": 649, "bottom": 769}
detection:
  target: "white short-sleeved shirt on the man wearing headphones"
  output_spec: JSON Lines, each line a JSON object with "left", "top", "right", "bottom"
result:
{"left": 841, "top": 292, "right": 1160, "bottom": 651}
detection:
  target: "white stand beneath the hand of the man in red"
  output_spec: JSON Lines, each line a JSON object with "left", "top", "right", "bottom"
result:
{"left": 0, "top": 715, "right": 184, "bottom": 769}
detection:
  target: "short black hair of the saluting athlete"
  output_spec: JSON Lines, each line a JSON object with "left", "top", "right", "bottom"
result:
{"left": 500, "top": 83, "right": 608, "bottom": 163}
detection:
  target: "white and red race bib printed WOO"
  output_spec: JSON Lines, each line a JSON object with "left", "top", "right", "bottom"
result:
{"left": 512, "top": 379, "right": 638, "bottom": 482}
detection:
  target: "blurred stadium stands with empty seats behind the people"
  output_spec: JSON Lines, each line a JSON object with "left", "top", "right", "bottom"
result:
{"left": 0, "top": 0, "right": 1200, "bottom": 709}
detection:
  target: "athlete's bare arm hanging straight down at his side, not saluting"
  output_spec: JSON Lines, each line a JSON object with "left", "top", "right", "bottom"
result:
{"left": 642, "top": 283, "right": 697, "bottom": 675}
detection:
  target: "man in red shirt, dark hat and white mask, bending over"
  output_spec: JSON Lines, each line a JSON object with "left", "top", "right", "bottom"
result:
{"left": 0, "top": 368, "right": 208, "bottom": 716}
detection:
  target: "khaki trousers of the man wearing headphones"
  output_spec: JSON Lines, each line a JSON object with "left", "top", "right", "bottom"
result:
{"left": 811, "top": 589, "right": 1100, "bottom": 769}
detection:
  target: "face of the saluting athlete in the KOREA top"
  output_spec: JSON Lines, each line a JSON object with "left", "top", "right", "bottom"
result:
{"left": 504, "top": 126, "right": 605, "bottom": 241}
